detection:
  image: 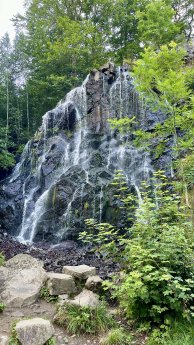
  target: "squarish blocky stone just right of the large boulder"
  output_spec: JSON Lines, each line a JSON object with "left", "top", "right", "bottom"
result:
{"left": 47, "top": 272, "right": 75, "bottom": 295}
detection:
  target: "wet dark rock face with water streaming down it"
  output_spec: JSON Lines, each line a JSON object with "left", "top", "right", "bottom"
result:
{"left": 0, "top": 63, "right": 170, "bottom": 243}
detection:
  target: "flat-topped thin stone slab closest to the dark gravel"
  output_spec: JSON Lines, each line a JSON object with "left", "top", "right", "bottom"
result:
{"left": 63, "top": 265, "right": 96, "bottom": 279}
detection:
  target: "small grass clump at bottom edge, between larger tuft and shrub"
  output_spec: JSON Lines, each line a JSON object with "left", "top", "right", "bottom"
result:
{"left": 100, "top": 328, "right": 132, "bottom": 345}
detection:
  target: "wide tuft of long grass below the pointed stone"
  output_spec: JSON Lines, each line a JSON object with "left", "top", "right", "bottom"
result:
{"left": 55, "top": 303, "right": 114, "bottom": 334}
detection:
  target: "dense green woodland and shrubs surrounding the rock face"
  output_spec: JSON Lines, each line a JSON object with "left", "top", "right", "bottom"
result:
{"left": 0, "top": 0, "right": 194, "bottom": 345}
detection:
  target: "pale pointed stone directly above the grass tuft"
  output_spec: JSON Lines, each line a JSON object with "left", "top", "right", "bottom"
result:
{"left": 66, "top": 289, "right": 100, "bottom": 307}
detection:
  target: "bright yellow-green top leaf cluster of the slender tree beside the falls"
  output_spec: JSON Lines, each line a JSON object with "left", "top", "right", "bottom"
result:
{"left": 134, "top": 42, "right": 187, "bottom": 106}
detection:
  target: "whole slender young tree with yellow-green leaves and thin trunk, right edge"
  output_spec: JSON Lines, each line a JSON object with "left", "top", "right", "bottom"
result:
{"left": 134, "top": 42, "right": 194, "bottom": 209}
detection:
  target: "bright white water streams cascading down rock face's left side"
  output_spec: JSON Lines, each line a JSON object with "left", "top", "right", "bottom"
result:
{"left": 18, "top": 78, "right": 87, "bottom": 243}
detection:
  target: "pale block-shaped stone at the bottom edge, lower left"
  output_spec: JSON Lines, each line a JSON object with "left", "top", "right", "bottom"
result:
{"left": 15, "top": 318, "right": 54, "bottom": 345}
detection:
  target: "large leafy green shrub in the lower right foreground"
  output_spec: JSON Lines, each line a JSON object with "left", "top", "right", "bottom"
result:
{"left": 81, "top": 172, "right": 194, "bottom": 324}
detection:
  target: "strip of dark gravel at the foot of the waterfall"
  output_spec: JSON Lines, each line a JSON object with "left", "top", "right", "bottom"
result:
{"left": 0, "top": 231, "right": 119, "bottom": 279}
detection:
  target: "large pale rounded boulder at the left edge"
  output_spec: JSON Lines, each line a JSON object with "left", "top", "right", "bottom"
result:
{"left": 0, "top": 254, "right": 47, "bottom": 307}
